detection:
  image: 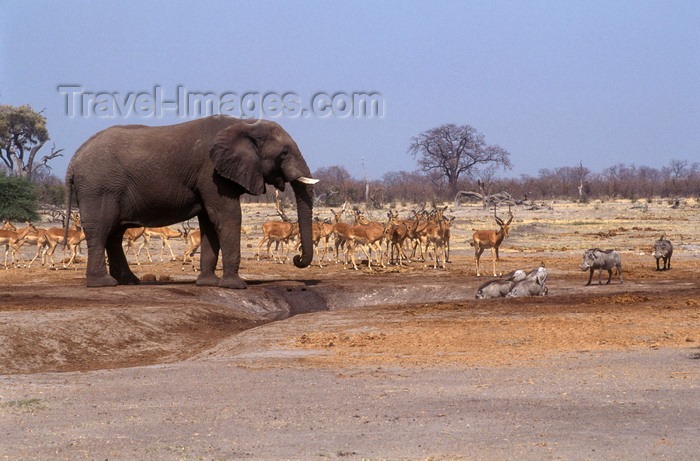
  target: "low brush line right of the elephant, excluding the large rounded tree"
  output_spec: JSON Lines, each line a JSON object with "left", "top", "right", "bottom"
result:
{"left": 304, "top": 160, "right": 700, "bottom": 206}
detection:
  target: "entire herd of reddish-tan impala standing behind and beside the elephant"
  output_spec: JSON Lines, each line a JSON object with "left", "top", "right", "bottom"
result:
{"left": 0, "top": 207, "right": 513, "bottom": 276}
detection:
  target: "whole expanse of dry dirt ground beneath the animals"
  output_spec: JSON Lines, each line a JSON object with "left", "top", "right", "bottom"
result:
{"left": 0, "top": 202, "right": 700, "bottom": 460}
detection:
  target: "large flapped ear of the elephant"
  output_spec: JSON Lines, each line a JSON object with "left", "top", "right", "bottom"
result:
{"left": 209, "top": 124, "right": 265, "bottom": 195}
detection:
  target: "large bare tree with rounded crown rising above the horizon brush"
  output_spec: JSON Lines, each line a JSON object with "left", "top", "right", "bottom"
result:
{"left": 408, "top": 124, "right": 511, "bottom": 197}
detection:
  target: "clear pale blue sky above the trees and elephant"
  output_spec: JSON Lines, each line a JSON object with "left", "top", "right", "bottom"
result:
{"left": 0, "top": 0, "right": 700, "bottom": 179}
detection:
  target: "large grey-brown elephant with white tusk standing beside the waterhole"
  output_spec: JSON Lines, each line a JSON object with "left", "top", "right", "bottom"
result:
{"left": 66, "top": 115, "right": 318, "bottom": 289}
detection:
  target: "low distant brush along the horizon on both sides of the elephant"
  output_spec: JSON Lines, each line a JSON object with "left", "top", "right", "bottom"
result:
{"left": 6, "top": 160, "right": 700, "bottom": 221}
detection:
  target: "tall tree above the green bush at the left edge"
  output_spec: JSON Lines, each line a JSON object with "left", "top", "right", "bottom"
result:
{"left": 0, "top": 105, "right": 63, "bottom": 180}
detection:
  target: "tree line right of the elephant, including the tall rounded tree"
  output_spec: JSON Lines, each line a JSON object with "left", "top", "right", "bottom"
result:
{"left": 304, "top": 124, "right": 700, "bottom": 206}
